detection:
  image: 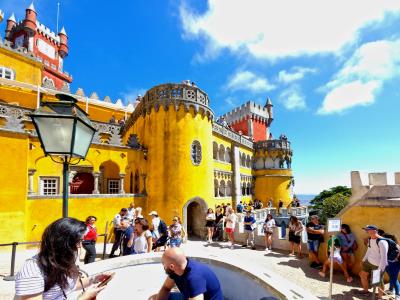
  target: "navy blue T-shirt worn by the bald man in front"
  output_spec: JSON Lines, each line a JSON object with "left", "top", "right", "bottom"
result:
{"left": 169, "top": 259, "right": 224, "bottom": 300}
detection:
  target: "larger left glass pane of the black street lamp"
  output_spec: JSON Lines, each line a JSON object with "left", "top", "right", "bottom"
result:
{"left": 35, "top": 115, "right": 74, "bottom": 154}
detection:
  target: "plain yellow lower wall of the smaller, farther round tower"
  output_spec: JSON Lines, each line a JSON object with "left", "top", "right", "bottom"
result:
{"left": 253, "top": 169, "right": 292, "bottom": 207}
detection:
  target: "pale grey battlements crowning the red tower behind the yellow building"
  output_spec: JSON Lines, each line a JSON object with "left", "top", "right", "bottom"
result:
{"left": 221, "top": 101, "right": 272, "bottom": 125}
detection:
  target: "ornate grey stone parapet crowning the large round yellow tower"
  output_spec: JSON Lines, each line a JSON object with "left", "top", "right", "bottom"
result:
{"left": 124, "top": 83, "right": 214, "bottom": 132}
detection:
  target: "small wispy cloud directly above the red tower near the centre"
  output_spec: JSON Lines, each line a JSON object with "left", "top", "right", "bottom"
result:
{"left": 226, "top": 71, "right": 275, "bottom": 93}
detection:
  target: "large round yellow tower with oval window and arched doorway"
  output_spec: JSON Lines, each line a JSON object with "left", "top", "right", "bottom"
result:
{"left": 123, "top": 83, "right": 214, "bottom": 235}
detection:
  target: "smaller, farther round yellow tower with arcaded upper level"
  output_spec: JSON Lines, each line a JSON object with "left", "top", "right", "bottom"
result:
{"left": 253, "top": 135, "right": 294, "bottom": 207}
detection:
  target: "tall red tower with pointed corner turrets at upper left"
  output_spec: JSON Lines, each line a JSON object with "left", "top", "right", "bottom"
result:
{"left": 6, "top": 3, "right": 72, "bottom": 91}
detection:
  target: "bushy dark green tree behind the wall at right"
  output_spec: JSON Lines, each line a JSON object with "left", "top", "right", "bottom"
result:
{"left": 310, "top": 185, "right": 351, "bottom": 223}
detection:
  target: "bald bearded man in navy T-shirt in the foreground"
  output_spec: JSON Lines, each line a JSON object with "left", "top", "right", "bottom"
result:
{"left": 150, "top": 248, "right": 224, "bottom": 300}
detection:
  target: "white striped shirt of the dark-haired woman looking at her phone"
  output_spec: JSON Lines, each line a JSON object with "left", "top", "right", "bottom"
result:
{"left": 15, "top": 255, "right": 76, "bottom": 300}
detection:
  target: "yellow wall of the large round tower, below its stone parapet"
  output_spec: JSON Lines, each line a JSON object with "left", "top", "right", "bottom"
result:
{"left": 126, "top": 105, "right": 214, "bottom": 220}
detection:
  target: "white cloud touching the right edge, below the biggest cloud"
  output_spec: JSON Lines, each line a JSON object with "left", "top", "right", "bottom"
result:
{"left": 318, "top": 40, "right": 400, "bottom": 114}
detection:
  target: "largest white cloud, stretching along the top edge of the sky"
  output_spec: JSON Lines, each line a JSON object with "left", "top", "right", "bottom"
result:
{"left": 180, "top": 0, "right": 400, "bottom": 59}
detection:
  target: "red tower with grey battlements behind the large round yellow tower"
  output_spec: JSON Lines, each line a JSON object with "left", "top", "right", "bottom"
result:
{"left": 221, "top": 98, "right": 273, "bottom": 142}
